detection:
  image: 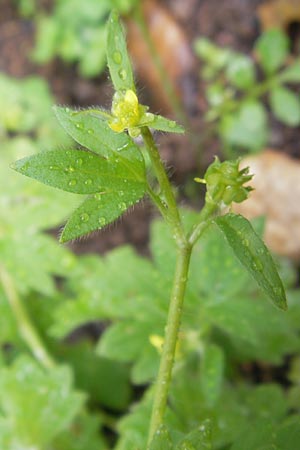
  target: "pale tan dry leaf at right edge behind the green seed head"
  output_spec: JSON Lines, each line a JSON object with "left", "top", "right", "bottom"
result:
{"left": 233, "top": 150, "right": 300, "bottom": 259}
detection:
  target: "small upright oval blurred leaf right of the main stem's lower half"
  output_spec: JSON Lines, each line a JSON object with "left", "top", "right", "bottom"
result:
{"left": 200, "top": 344, "right": 225, "bottom": 406}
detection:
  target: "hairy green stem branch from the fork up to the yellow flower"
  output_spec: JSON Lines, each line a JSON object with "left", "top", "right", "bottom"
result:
{"left": 142, "top": 127, "right": 186, "bottom": 245}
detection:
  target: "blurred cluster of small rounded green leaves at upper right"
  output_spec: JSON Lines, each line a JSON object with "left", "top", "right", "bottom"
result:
{"left": 195, "top": 29, "right": 300, "bottom": 155}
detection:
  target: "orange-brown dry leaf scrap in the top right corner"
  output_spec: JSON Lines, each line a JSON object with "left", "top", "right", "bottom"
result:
{"left": 257, "top": 0, "right": 300, "bottom": 30}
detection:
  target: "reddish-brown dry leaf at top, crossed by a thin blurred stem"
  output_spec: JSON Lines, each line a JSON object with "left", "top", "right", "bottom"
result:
{"left": 127, "top": 0, "right": 194, "bottom": 112}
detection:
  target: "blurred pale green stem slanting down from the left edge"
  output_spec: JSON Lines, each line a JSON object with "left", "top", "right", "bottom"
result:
{"left": 0, "top": 265, "right": 55, "bottom": 369}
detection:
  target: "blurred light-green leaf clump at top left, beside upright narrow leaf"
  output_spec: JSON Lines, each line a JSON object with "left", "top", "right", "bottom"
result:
{"left": 18, "top": 0, "right": 140, "bottom": 77}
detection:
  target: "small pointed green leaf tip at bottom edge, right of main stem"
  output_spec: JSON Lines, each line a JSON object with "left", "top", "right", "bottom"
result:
{"left": 176, "top": 420, "right": 213, "bottom": 450}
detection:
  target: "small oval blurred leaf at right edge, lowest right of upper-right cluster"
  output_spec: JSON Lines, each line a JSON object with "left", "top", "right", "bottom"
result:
{"left": 270, "top": 86, "right": 300, "bottom": 127}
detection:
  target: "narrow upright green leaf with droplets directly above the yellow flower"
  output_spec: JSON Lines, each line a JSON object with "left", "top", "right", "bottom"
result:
{"left": 106, "top": 12, "right": 135, "bottom": 92}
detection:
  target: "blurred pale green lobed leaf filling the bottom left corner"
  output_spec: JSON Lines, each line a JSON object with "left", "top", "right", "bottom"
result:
{"left": 0, "top": 357, "right": 84, "bottom": 450}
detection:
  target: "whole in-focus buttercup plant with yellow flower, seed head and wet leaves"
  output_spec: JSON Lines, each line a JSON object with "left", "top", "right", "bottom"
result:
{"left": 13, "top": 13, "right": 286, "bottom": 450}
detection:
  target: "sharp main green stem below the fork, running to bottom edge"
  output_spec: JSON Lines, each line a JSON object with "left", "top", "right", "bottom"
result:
{"left": 148, "top": 245, "right": 192, "bottom": 448}
